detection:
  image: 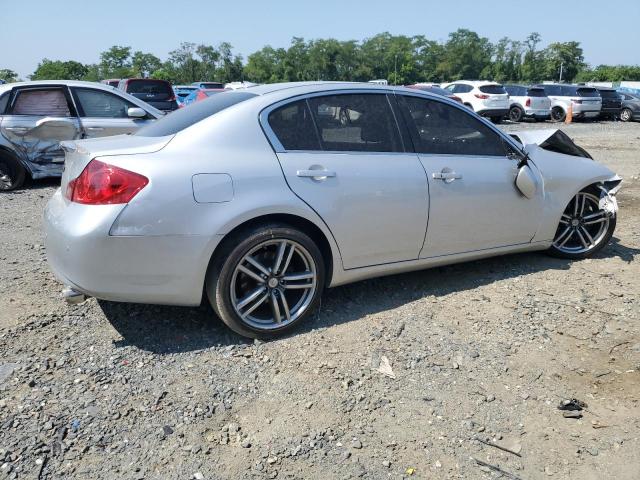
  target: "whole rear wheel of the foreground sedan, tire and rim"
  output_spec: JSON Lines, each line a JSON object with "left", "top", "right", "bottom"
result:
{"left": 206, "top": 224, "right": 325, "bottom": 338}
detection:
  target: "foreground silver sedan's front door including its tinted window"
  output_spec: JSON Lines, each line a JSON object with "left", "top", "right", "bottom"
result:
{"left": 400, "top": 96, "right": 543, "bottom": 258}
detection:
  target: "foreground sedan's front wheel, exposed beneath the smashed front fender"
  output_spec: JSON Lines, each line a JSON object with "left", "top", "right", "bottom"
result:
{"left": 549, "top": 190, "right": 616, "bottom": 260}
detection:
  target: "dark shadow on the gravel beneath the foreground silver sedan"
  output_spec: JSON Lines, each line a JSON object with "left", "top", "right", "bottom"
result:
{"left": 98, "top": 238, "right": 640, "bottom": 354}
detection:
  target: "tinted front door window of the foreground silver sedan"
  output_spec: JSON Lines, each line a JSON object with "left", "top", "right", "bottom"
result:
{"left": 400, "top": 96, "right": 505, "bottom": 156}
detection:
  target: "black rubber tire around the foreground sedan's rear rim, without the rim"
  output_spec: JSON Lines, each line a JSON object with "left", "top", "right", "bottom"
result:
{"left": 205, "top": 223, "right": 326, "bottom": 339}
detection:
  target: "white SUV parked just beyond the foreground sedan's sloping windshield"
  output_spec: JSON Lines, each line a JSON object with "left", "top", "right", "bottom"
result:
{"left": 444, "top": 80, "right": 509, "bottom": 123}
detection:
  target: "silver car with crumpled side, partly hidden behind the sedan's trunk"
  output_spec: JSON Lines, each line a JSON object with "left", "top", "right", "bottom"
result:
{"left": 0, "top": 80, "right": 163, "bottom": 190}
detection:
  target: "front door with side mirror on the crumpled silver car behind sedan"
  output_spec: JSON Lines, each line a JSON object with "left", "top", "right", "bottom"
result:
{"left": 71, "top": 87, "right": 153, "bottom": 138}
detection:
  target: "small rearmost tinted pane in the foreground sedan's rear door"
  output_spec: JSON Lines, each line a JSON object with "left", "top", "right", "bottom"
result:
{"left": 269, "top": 100, "right": 321, "bottom": 150}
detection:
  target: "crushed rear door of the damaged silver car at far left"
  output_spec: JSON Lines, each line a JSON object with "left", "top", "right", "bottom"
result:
{"left": 0, "top": 85, "right": 80, "bottom": 172}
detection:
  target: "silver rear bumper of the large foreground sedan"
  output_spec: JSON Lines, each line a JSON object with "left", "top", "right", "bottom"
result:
{"left": 44, "top": 190, "right": 219, "bottom": 305}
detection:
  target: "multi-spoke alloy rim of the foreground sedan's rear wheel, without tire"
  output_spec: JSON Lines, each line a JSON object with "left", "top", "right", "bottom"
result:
{"left": 230, "top": 239, "right": 318, "bottom": 330}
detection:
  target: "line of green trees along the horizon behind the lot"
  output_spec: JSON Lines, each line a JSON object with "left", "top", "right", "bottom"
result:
{"left": 0, "top": 29, "right": 640, "bottom": 85}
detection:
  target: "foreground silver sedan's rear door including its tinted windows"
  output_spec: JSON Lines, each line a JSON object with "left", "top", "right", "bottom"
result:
{"left": 263, "top": 92, "right": 429, "bottom": 269}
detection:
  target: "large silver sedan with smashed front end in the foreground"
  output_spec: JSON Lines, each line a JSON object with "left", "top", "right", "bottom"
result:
{"left": 45, "top": 82, "right": 621, "bottom": 337}
